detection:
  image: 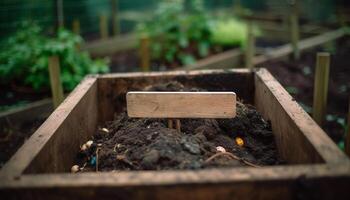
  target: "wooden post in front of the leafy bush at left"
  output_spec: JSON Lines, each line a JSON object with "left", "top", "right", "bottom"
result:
{"left": 49, "top": 56, "right": 64, "bottom": 108}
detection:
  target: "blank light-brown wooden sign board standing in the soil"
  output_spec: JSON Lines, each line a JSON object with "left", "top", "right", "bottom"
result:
{"left": 126, "top": 92, "right": 236, "bottom": 118}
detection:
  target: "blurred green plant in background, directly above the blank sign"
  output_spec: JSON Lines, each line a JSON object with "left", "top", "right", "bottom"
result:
{"left": 138, "top": 0, "right": 211, "bottom": 64}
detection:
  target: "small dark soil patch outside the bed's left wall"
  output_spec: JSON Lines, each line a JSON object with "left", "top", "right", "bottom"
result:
{"left": 0, "top": 118, "right": 45, "bottom": 168}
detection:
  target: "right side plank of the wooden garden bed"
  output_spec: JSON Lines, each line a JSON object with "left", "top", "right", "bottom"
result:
{"left": 255, "top": 68, "right": 348, "bottom": 164}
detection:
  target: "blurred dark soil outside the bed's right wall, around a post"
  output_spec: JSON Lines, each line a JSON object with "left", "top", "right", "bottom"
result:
{"left": 260, "top": 37, "right": 350, "bottom": 146}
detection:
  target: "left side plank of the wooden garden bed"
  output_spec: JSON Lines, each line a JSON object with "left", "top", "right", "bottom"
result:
{"left": 1, "top": 77, "right": 98, "bottom": 177}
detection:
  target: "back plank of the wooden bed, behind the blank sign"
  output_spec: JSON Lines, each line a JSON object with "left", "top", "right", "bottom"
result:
{"left": 98, "top": 69, "right": 254, "bottom": 123}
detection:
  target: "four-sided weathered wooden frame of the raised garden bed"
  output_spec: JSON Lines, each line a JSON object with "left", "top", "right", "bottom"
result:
{"left": 0, "top": 69, "right": 350, "bottom": 200}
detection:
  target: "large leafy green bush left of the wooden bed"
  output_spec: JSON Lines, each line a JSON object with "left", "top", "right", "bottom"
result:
{"left": 0, "top": 22, "right": 108, "bottom": 91}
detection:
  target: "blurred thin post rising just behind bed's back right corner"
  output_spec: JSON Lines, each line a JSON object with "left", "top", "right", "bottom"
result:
{"left": 245, "top": 20, "right": 255, "bottom": 69}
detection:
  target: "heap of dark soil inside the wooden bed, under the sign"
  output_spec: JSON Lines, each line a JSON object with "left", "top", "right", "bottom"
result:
{"left": 77, "top": 82, "right": 282, "bottom": 171}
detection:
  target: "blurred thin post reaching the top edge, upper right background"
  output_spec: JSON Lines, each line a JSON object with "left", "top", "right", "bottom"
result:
{"left": 290, "top": 0, "right": 300, "bottom": 60}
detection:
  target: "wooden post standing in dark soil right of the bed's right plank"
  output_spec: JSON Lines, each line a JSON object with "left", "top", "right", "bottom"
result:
{"left": 312, "top": 52, "right": 330, "bottom": 125}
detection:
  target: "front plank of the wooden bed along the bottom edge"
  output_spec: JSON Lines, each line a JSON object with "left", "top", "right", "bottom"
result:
{"left": 0, "top": 164, "right": 350, "bottom": 200}
